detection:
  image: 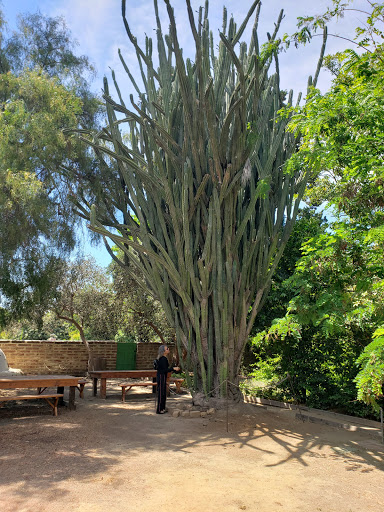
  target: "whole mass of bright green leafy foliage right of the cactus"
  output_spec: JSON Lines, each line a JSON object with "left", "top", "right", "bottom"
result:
{"left": 249, "top": 1, "right": 384, "bottom": 414}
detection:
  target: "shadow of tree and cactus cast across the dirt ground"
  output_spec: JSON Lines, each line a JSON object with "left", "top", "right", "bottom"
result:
{"left": 0, "top": 384, "right": 384, "bottom": 499}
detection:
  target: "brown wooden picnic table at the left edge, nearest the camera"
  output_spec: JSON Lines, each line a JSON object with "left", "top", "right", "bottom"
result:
{"left": 0, "top": 375, "right": 79, "bottom": 410}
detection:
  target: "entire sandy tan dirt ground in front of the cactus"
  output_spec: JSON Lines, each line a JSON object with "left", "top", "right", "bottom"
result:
{"left": 0, "top": 385, "right": 384, "bottom": 512}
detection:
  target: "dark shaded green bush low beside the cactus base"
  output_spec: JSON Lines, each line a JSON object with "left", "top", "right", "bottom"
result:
{"left": 251, "top": 326, "right": 378, "bottom": 416}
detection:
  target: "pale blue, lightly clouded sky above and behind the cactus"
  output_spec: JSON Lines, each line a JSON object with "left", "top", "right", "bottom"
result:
{"left": 0, "top": 0, "right": 368, "bottom": 266}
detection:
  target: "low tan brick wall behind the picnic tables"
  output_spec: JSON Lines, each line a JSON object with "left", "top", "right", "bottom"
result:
{"left": 0, "top": 340, "right": 175, "bottom": 376}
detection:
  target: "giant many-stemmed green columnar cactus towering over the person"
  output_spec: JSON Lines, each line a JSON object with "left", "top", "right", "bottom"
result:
{"left": 71, "top": 0, "right": 324, "bottom": 396}
